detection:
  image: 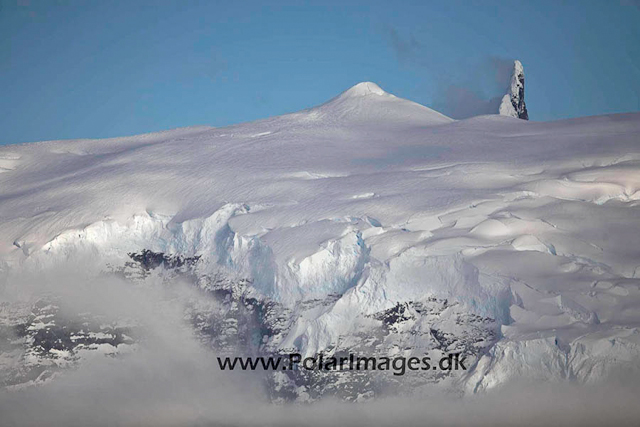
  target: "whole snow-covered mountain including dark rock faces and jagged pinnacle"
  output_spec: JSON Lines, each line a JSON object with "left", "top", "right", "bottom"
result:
{"left": 0, "top": 82, "right": 640, "bottom": 400}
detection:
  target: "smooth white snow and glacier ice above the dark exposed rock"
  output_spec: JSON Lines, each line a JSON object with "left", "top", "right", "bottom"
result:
{"left": 0, "top": 82, "right": 640, "bottom": 392}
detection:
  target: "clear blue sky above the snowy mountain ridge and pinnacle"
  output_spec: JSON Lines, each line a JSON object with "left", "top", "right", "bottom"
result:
{"left": 0, "top": 0, "right": 640, "bottom": 144}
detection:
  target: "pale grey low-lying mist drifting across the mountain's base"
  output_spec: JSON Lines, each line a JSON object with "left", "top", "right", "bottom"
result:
{"left": 0, "top": 271, "right": 640, "bottom": 427}
